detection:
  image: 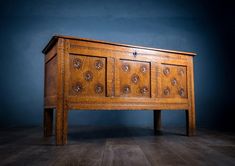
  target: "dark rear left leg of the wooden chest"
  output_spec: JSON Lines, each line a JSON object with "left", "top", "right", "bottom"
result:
{"left": 43, "top": 108, "right": 54, "bottom": 137}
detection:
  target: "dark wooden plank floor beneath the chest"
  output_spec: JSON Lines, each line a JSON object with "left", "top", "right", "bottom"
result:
{"left": 0, "top": 127, "right": 235, "bottom": 166}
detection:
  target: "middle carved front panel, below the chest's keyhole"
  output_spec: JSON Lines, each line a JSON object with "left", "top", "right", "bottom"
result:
{"left": 119, "top": 60, "right": 151, "bottom": 97}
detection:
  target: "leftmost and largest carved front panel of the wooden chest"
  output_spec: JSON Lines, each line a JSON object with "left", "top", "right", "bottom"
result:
{"left": 69, "top": 55, "right": 106, "bottom": 97}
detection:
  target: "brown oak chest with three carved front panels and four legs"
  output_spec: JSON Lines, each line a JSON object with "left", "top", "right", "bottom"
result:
{"left": 43, "top": 36, "right": 195, "bottom": 145}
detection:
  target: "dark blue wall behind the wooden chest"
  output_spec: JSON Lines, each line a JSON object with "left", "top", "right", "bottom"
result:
{"left": 0, "top": 0, "right": 235, "bottom": 129}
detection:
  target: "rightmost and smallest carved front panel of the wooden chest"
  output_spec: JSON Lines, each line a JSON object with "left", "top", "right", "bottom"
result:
{"left": 160, "top": 64, "right": 188, "bottom": 98}
